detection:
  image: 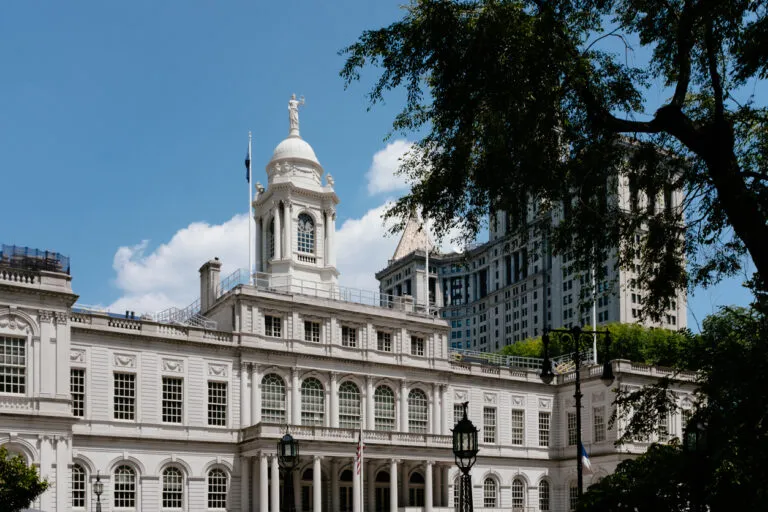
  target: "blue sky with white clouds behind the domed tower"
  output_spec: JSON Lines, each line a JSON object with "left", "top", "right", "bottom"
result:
{"left": 0, "top": 0, "right": 748, "bottom": 326}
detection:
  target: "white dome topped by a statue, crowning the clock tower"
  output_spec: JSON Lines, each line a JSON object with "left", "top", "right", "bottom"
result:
{"left": 267, "top": 94, "right": 323, "bottom": 188}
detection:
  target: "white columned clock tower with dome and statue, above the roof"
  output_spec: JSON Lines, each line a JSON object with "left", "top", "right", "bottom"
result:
{"left": 253, "top": 94, "right": 339, "bottom": 286}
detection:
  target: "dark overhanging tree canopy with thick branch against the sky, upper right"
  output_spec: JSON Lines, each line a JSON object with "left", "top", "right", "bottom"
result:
{"left": 341, "top": 0, "right": 768, "bottom": 318}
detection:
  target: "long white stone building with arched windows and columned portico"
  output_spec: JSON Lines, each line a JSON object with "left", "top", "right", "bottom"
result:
{"left": 0, "top": 97, "right": 688, "bottom": 512}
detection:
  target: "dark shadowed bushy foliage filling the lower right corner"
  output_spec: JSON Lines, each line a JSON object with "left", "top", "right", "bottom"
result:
{"left": 580, "top": 308, "right": 768, "bottom": 511}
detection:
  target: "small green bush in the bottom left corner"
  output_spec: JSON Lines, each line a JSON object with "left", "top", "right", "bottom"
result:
{"left": 0, "top": 448, "right": 48, "bottom": 512}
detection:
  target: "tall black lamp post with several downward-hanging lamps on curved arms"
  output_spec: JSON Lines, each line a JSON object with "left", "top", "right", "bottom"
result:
{"left": 540, "top": 325, "right": 614, "bottom": 499}
